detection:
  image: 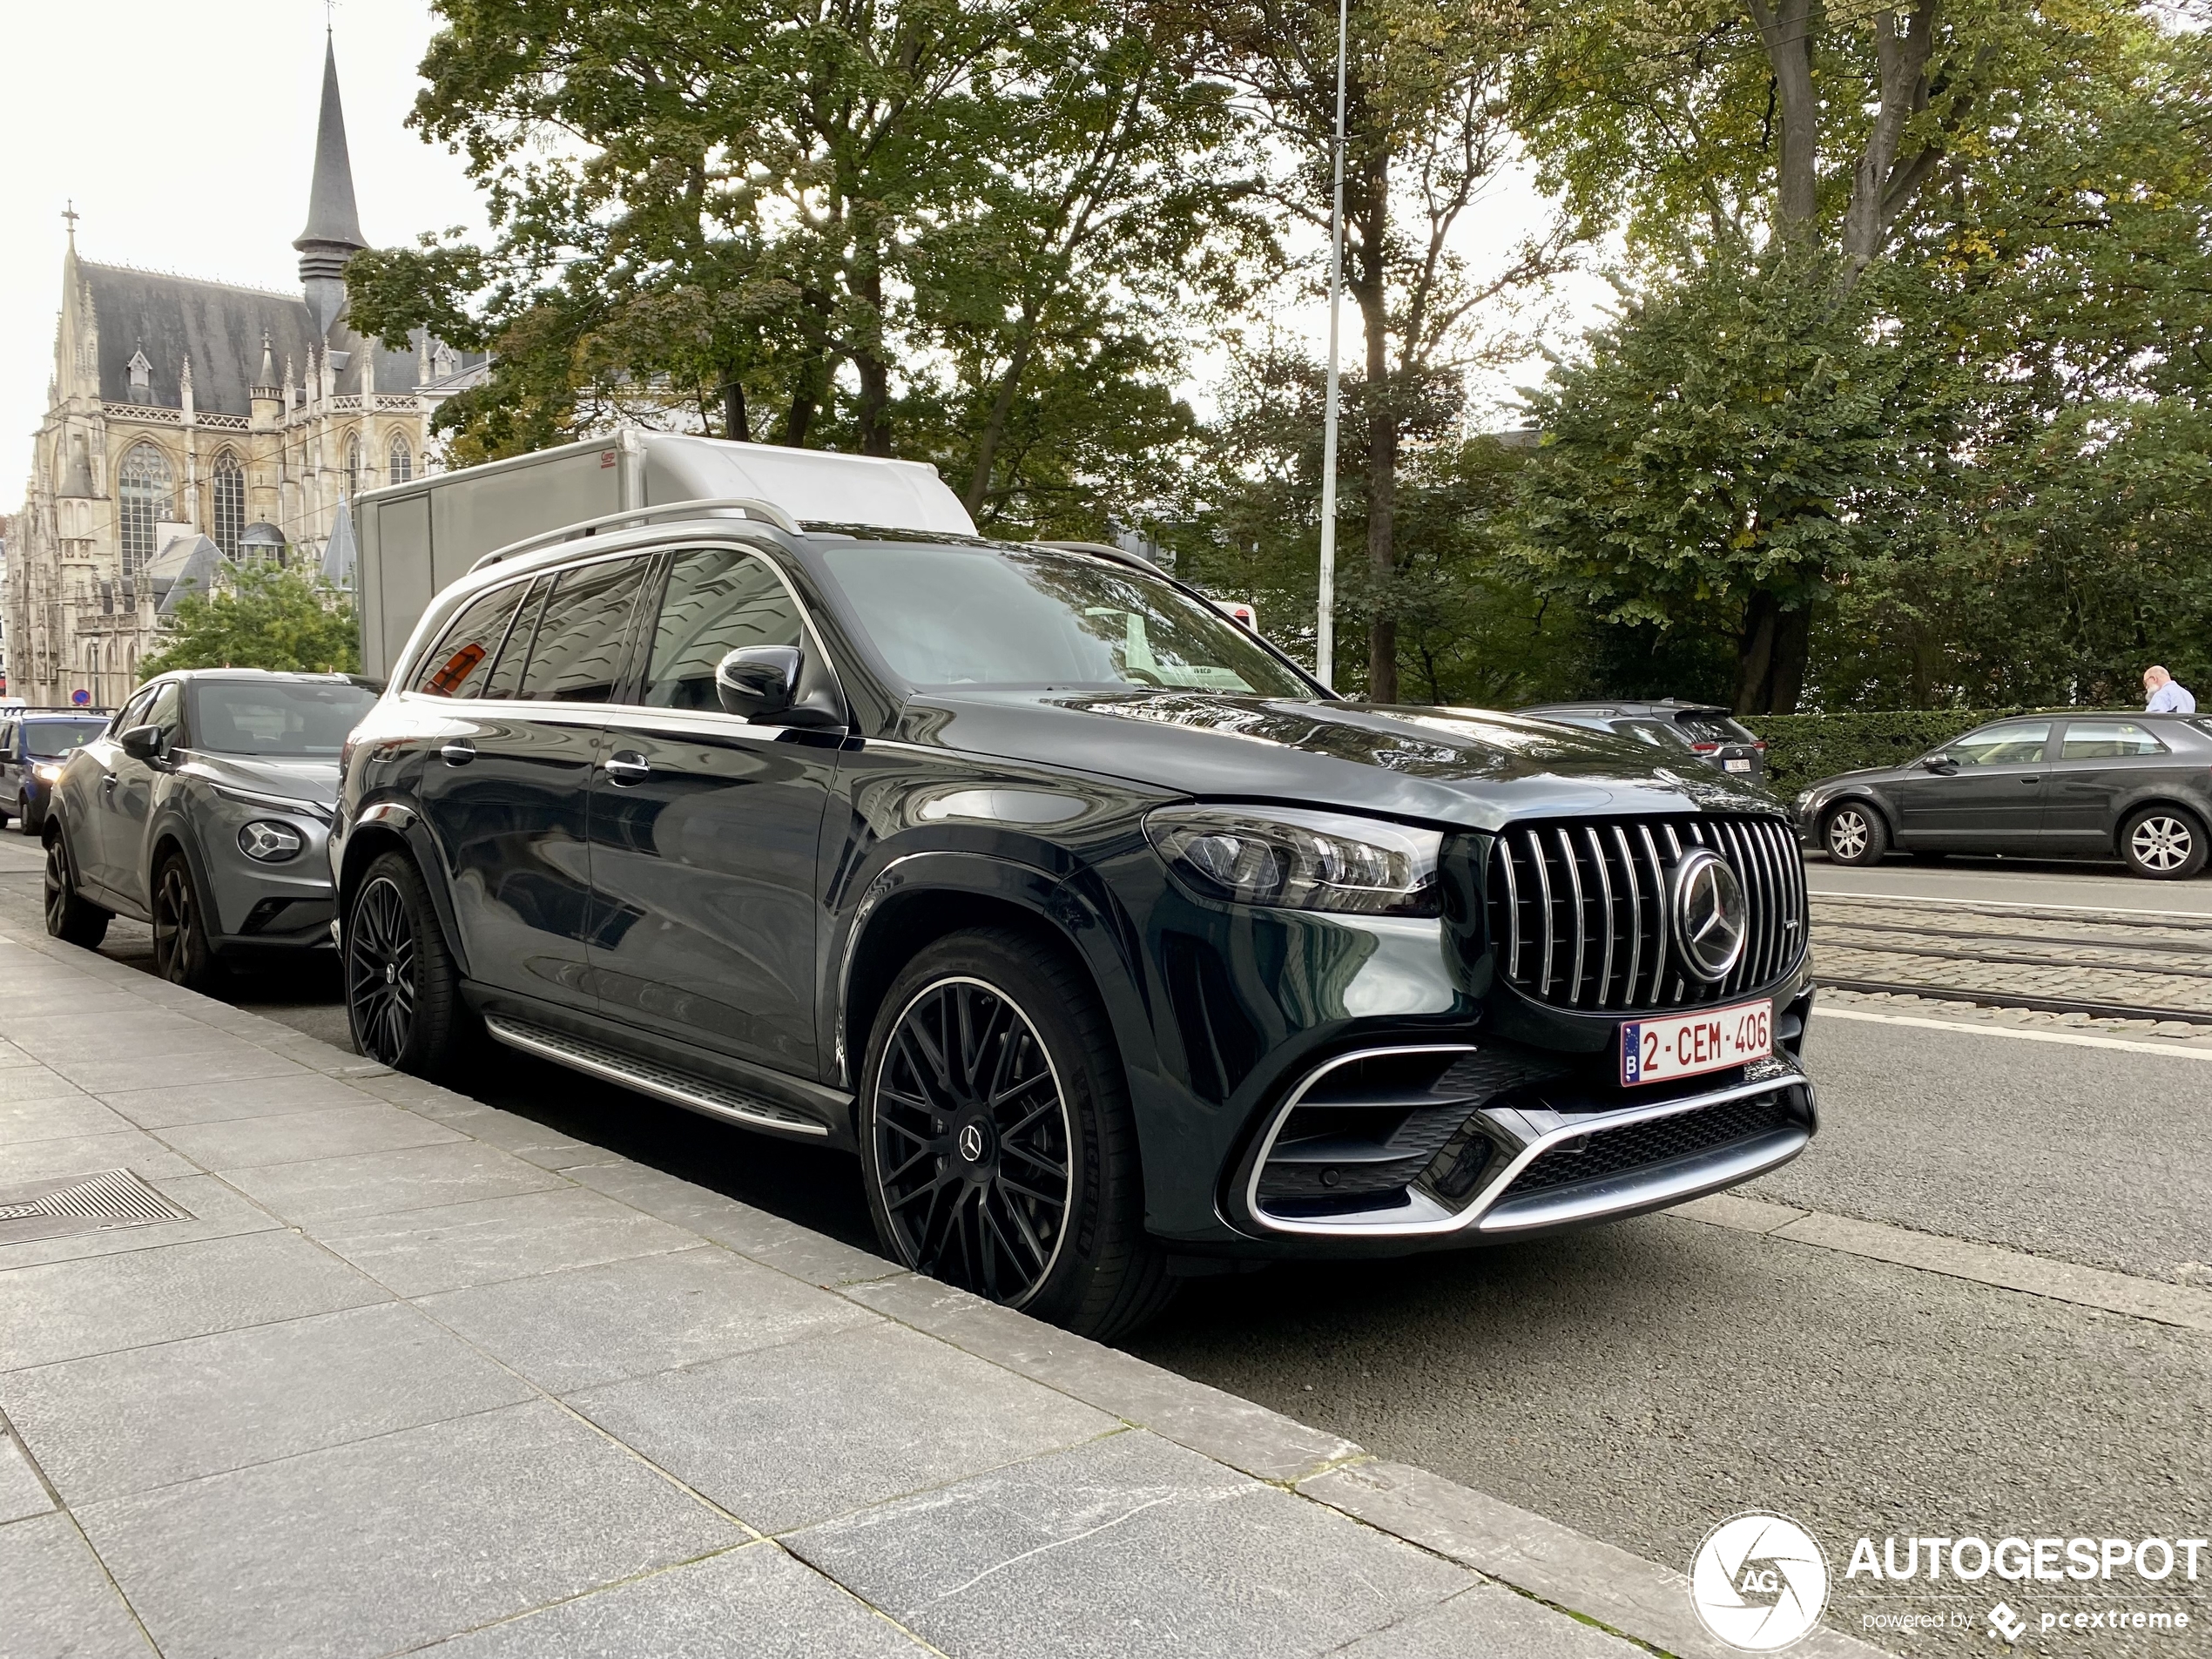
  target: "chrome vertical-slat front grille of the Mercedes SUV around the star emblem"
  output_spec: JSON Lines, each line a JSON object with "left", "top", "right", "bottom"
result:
{"left": 1488, "top": 816, "right": 1805, "bottom": 1011}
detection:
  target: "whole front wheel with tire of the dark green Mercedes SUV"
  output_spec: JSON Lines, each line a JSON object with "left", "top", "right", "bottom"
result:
{"left": 859, "top": 929, "right": 1177, "bottom": 1340}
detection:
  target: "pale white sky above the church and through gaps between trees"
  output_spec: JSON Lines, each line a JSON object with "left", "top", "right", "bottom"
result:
{"left": 0, "top": 0, "right": 1602, "bottom": 511}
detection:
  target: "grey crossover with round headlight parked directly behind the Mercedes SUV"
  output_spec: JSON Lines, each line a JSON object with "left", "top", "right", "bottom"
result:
{"left": 44, "top": 668, "right": 376, "bottom": 987}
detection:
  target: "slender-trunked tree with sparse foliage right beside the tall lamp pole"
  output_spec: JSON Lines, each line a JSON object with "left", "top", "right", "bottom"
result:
{"left": 1204, "top": 0, "right": 1570, "bottom": 704}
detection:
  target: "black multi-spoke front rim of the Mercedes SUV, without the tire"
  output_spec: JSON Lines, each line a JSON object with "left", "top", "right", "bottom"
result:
{"left": 873, "top": 978, "right": 1075, "bottom": 1307}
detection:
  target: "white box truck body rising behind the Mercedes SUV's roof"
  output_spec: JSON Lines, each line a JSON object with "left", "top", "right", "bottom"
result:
{"left": 354, "top": 429, "right": 975, "bottom": 679}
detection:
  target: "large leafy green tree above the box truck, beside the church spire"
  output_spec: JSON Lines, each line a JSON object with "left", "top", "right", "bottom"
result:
{"left": 349, "top": 0, "right": 1252, "bottom": 524}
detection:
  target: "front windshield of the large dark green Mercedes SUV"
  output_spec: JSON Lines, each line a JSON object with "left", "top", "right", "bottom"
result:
{"left": 823, "top": 542, "right": 1316, "bottom": 699}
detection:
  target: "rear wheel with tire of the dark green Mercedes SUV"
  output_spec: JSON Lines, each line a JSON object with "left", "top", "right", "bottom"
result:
{"left": 343, "top": 852, "right": 475, "bottom": 1077}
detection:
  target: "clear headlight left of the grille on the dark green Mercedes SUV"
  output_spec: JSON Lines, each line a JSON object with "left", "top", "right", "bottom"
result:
{"left": 1143, "top": 807, "right": 1445, "bottom": 916}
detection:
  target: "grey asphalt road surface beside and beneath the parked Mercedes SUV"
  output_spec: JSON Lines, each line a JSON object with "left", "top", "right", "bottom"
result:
{"left": 0, "top": 845, "right": 2212, "bottom": 1655}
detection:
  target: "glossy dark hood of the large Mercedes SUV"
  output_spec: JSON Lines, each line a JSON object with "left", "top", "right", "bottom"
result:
{"left": 898, "top": 690, "right": 1778, "bottom": 830}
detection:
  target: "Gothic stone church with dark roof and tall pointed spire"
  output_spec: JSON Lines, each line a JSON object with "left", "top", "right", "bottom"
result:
{"left": 4, "top": 38, "right": 480, "bottom": 708}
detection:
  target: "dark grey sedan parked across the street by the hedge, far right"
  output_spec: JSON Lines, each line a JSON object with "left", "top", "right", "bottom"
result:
{"left": 1794, "top": 710, "right": 2212, "bottom": 880}
